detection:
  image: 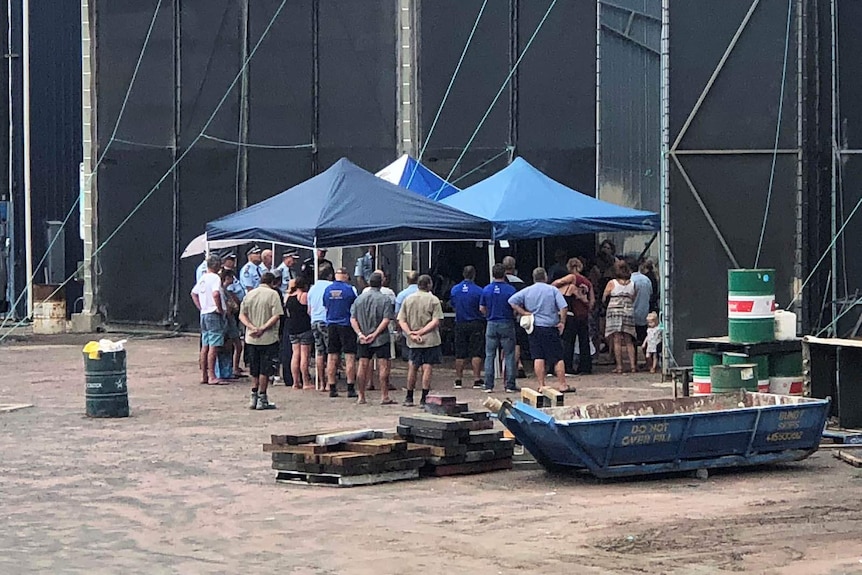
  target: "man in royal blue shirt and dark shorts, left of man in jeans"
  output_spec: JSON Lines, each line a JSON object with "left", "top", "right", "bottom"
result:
{"left": 449, "top": 266, "right": 485, "bottom": 389}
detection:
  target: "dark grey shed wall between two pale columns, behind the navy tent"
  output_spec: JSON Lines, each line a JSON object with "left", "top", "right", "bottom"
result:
{"left": 97, "top": 0, "right": 397, "bottom": 325}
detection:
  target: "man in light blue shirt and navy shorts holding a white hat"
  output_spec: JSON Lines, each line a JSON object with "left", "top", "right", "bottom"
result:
{"left": 509, "top": 268, "right": 574, "bottom": 391}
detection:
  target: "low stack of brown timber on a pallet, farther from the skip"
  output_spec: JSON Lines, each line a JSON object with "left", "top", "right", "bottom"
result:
{"left": 263, "top": 429, "right": 431, "bottom": 487}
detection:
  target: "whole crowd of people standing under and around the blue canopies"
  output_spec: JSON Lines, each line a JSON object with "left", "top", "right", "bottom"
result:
{"left": 191, "top": 240, "right": 661, "bottom": 410}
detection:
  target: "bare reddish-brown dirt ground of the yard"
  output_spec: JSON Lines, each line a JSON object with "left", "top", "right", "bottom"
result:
{"left": 0, "top": 337, "right": 862, "bottom": 575}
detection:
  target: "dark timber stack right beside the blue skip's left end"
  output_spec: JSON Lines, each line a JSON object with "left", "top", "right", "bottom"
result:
{"left": 397, "top": 410, "right": 515, "bottom": 477}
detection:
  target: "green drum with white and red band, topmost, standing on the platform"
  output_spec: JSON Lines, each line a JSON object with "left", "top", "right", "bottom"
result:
{"left": 727, "top": 269, "right": 775, "bottom": 343}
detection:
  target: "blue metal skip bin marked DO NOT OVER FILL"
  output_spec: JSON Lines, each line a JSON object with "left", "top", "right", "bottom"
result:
{"left": 496, "top": 390, "right": 829, "bottom": 478}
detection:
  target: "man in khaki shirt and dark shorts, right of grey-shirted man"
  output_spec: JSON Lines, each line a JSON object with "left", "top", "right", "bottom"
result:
{"left": 398, "top": 275, "right": 443, "bottom": 406}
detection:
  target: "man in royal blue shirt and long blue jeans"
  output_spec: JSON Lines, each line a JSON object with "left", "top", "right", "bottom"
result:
{"left": 479, "top": 264, "right": 518, "bottom": 393}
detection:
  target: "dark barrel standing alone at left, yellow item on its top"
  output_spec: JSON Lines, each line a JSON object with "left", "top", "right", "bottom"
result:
{"left": 84, "top": 350, "right": 129, "bottom": 417}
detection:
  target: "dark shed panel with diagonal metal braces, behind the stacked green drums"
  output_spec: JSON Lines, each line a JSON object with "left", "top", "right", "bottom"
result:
{"left": 665, "top": 0, "right": 801, "bottom": 363}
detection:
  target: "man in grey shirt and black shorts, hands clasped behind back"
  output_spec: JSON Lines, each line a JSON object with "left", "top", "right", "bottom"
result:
{"left": 350, "top": 272, "right": 395, "bottom": 405}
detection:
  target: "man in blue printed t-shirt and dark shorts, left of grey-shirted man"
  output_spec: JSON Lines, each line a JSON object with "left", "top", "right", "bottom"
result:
{"left": 323, "top": 268, "right": 359, "bottom": 398}
